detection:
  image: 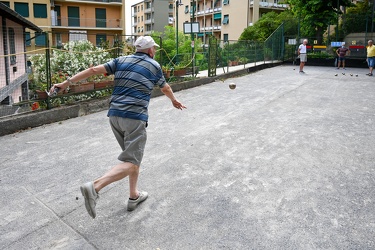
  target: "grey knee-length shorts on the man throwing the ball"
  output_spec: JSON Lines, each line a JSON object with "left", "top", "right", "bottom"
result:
{"left": 109, "top": 116, "right": 147, "bottom": 166}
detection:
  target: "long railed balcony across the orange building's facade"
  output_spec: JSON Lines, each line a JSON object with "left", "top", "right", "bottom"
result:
{"left": 52, "top": 17, "right": 122, "bottom": 29}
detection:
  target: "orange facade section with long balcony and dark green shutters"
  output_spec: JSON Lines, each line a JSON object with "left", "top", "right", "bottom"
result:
{"left": 51, "top": 0, "right": 125, "bottom": 47}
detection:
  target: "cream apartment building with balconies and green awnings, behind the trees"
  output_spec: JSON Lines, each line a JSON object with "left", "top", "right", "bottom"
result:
{"left": 175, "top": 0, "right": 288, "bottom": 44}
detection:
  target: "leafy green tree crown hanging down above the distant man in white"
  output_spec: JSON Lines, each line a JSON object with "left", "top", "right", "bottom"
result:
{"left": 286, "top": 0, "right": 353, "bottom": 43}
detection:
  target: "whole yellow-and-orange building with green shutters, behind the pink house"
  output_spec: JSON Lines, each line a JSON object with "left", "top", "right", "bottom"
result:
{"left": 2, "top": 0, "right": 125, "bottom": 51}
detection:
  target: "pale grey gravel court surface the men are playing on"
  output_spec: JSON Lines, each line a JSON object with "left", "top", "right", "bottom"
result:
{"left": 0, "top": 66, "right": 375, "bottom": 250}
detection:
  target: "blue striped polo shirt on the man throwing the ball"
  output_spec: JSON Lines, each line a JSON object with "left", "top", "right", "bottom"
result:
{"left": 104, "top": 52, "right": 166, "bottom": 121}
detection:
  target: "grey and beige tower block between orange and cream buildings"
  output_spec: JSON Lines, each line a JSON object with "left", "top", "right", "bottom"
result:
{"left": 131, "top": 0, "right": 173, "bottom": 39}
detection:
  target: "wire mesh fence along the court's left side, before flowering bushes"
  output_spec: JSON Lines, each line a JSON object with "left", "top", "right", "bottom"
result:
{"left": 0, "top": 29, "right": 283, "bottom": 116}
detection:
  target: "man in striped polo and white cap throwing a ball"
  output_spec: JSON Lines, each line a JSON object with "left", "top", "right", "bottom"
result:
{"left": 50, "top": 36, "right": 186, "bottom": 218}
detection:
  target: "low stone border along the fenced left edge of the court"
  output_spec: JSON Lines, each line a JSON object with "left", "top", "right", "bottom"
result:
{"left": 0, "top": 62, "right": 282, "bottom": 136}
